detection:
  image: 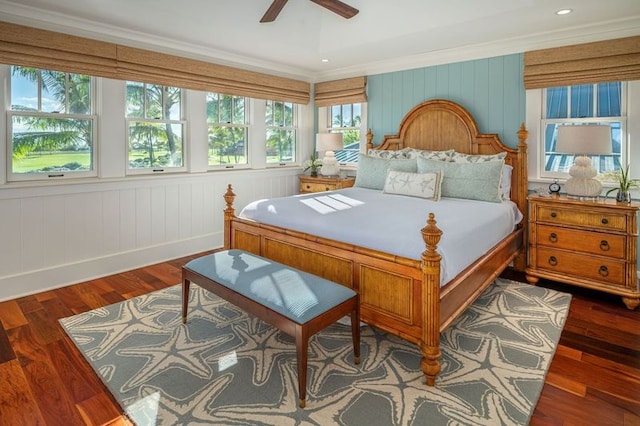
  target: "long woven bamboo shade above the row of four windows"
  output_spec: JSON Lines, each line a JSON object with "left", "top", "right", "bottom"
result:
{"left": 0, "top": 22, "right": 311, "bottom": 104}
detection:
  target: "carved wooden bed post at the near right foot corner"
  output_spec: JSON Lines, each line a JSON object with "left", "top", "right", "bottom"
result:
{"left": 420, "top": 213, "right": 442, "bottom": 386}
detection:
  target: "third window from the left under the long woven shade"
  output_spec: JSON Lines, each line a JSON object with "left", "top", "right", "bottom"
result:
{"left": 207, "top": 93, "right": 249, "bottom": 168}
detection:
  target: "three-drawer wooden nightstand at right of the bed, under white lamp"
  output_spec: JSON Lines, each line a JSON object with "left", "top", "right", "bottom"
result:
{"left": 525, "top": 195, "right": 640, "bottom": 309}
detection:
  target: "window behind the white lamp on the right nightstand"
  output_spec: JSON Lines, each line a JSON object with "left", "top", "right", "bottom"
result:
{"left": 540, "top": 82, "right": 629, "bottom": 178}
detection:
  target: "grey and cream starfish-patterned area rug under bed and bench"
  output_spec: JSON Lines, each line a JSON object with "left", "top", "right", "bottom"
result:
{"left": 60, "top": 278, "right": 571, "bottom": 426}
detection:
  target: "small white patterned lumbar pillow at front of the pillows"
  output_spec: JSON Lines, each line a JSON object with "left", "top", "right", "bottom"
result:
{"left": 383, "top": 170, "right": 442, "bottom": 201}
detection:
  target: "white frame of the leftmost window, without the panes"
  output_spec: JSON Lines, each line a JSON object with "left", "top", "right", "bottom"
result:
{"left": 5, "top": 65, "right": 99, "bottom": 182}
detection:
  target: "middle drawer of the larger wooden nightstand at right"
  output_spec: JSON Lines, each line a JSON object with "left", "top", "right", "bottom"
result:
{"left": 536, "top": 225, "right": 627, "bottom": 259}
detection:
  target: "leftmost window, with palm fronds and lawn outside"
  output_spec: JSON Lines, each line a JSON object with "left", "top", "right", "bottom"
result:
{"left": 7, "top": 66, "right": 97, "bottom": 181}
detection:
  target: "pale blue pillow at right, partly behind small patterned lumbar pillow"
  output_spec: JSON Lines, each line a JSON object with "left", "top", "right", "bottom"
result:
{"left": 418, "top": 157, "right": 504, "bottom": 203}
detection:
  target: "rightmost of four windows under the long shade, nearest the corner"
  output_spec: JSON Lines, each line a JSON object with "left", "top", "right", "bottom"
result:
{"left": 265, "top": 101, "right": 298, "bottom": 165}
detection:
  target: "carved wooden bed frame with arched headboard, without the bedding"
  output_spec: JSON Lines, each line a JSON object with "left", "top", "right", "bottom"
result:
{"left": 224, "top": 100, "right": 527, "bottom": 386}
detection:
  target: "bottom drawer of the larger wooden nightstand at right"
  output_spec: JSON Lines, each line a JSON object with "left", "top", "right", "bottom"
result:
{"left": 535, "top": 247, "right": 625, "bottom": 286}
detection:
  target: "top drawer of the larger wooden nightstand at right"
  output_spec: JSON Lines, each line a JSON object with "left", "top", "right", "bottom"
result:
{"left": 536, "top": 206, "right": 627, "bottom": 232}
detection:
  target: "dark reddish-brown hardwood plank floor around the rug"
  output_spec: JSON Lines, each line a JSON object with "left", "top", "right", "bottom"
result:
{"left": 0, "top": 253, "right": 640, "bottom": 426}
